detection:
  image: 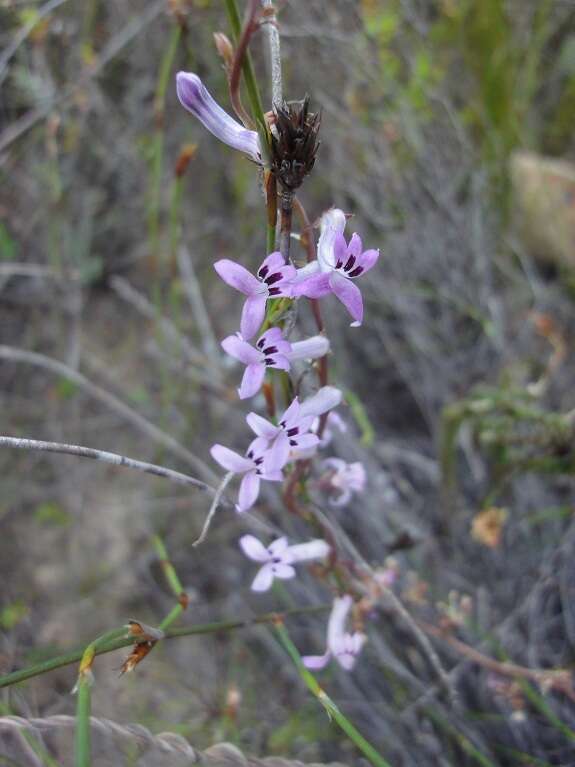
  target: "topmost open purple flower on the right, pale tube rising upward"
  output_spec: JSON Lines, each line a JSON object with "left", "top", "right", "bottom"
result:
{"left": 293, "top": 208, "right": 379, "bottom": 327}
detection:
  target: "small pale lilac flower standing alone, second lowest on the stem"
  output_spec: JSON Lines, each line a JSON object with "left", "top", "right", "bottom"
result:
{"left": 240, "top": 535, "right": 329, "bottom": 591}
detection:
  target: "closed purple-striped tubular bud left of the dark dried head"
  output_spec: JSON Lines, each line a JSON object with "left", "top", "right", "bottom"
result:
{"left": 176, "top": 72, "right": 261, "bottom": 163}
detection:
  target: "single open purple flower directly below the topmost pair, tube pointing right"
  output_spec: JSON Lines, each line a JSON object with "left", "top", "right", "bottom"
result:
{"left": 222, "top": 328, "right": 329, "bottom": 399}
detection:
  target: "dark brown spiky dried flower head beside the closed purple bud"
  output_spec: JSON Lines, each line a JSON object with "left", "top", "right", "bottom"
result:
{"left": 271, "top": 96, "right": 321, "bottom": 192}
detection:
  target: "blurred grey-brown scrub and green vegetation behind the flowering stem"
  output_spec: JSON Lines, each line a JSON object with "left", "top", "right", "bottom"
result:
{"left": 0, "top": 0, "right": 575, "bottom": 767}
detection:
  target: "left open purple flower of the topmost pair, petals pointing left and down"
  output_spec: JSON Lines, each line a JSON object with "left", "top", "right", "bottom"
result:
{"left": 214, "top": 251, "right": 296, "bottom": 341}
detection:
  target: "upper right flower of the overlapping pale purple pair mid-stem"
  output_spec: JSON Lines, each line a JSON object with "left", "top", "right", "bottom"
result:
{"left": 246, "top": 386, "right": 342, "bottom": 471}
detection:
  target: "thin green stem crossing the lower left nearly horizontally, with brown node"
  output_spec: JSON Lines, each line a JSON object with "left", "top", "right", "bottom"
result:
{"left": 0, "top": 605, "right": 330, "bottom": 689}
